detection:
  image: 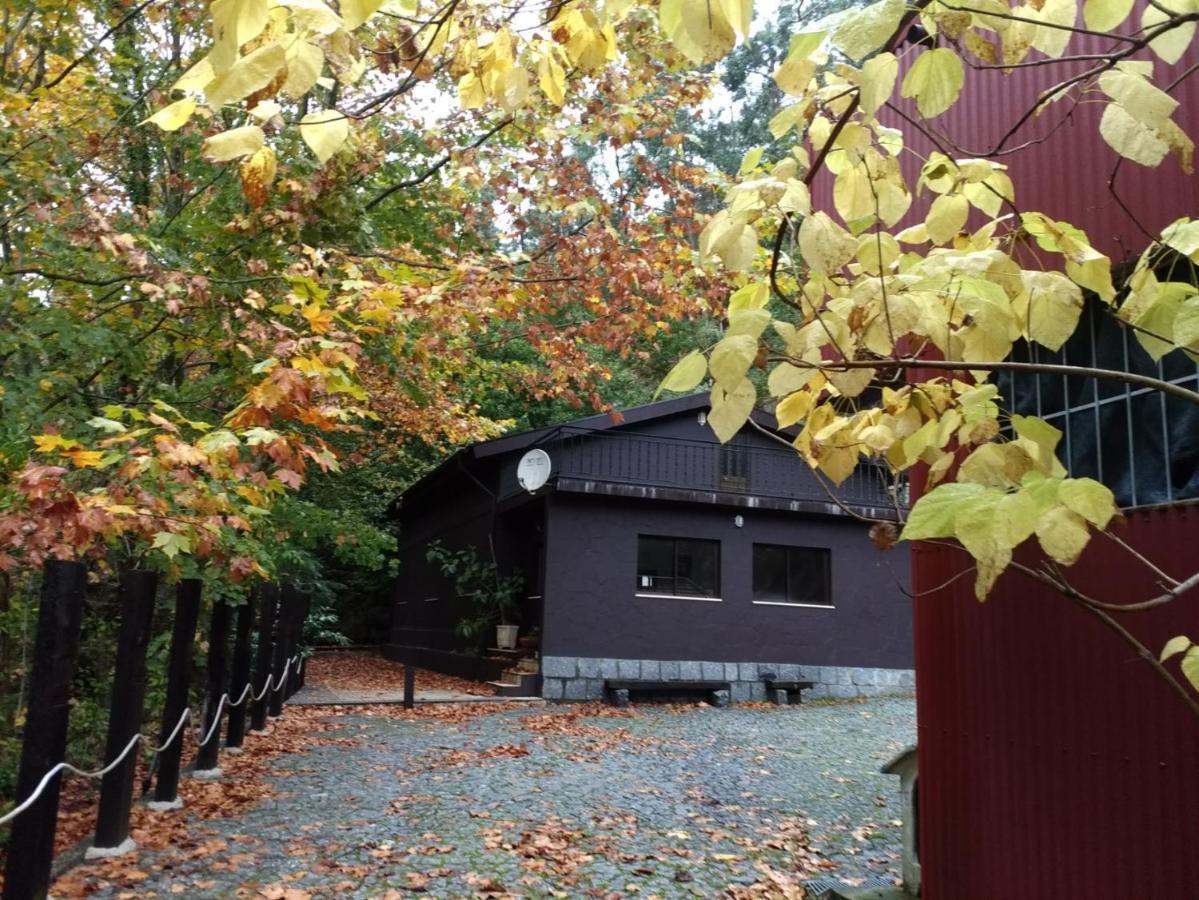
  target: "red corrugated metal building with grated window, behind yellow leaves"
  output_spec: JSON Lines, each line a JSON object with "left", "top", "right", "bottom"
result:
{"left": 839, "top": 13, "right": 1199, "bottom": 900}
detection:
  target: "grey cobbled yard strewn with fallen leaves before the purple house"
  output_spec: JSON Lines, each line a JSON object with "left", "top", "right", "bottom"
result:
{"left": 68, "top": 697, "right": 915, "bottom": 900}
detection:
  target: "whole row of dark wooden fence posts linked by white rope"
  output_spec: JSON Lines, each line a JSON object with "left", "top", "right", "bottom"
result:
{"left": 0, "top": 560, "right": 309, "bottom": 900}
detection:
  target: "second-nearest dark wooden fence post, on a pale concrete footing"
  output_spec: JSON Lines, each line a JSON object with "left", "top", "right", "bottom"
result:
{"left": 85, "top": 569, "right": 158, "bottom": 859}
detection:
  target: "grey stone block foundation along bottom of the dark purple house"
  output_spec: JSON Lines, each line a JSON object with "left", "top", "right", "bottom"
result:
{"left": 541, "top": 657, "right": 916, "bottom": 703}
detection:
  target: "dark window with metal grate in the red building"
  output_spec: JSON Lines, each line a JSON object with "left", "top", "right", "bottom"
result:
{"left": 996, "top": 300, "right": 1199, "bottom": 508}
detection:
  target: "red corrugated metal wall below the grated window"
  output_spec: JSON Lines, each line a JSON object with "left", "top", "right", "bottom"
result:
{"left": 912, "top": 507, "right": 1199, "bottom": 900}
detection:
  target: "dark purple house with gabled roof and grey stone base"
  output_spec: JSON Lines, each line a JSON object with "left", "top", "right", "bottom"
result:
{"left": 387, "top": 395, "right": 912, "bottom": 701}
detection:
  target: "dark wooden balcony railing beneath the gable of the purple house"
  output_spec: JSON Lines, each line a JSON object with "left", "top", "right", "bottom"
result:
{"left": 500, "top": 431, "right": 903, "bottom": 508}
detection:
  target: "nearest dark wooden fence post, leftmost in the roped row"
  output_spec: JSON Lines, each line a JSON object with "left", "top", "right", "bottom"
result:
{"left": 4, "top": 560, "right": 88, "bottom": 900}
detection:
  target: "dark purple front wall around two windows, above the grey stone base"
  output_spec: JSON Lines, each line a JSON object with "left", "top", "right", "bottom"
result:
{"left": 542, "top": 494, "right": 912, "bottom": 670}
